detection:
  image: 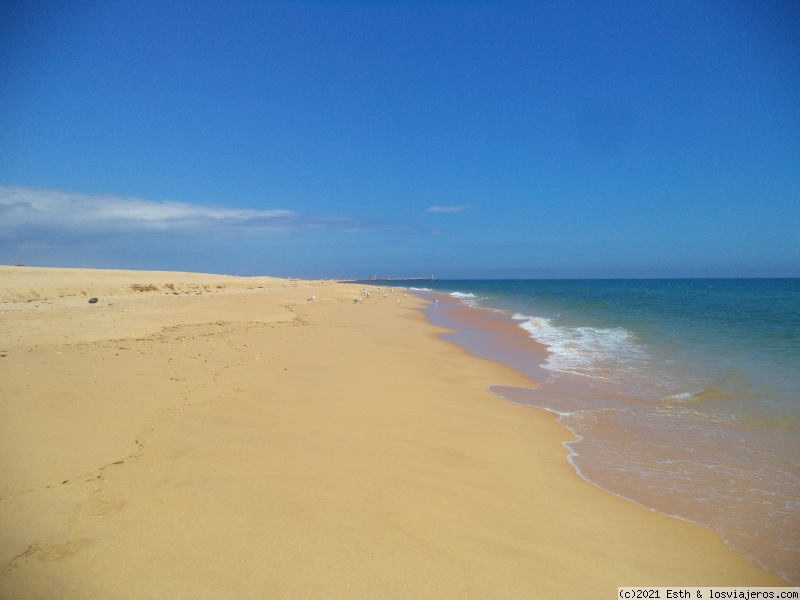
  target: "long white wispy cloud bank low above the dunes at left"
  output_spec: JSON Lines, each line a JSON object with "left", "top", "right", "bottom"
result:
{"left": 0, "top": 186, "right": 354, "bottom": 239}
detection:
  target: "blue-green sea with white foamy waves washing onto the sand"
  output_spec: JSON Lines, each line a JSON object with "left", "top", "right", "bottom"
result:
{"left": 404, "top": 279, "right": 800, "bottom": 584}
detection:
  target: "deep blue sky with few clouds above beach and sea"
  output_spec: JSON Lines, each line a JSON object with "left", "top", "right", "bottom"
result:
{"left": 0, "top": 0, "right": 800, "bottom": 278}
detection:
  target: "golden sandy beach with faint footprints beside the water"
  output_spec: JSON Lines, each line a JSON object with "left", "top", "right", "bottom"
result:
{"left": 0, "top": 266, "right": 785, "bottom": 600}
